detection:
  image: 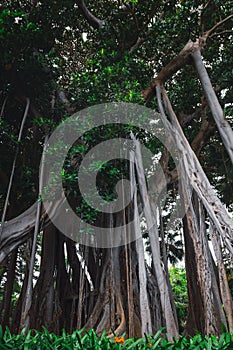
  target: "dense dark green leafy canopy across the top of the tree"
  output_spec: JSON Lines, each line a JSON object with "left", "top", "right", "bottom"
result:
{"left": 0, "top": 0, "right": 232, "bottom": 213}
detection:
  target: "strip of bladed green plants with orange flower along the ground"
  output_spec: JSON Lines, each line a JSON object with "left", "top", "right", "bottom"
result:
{"left": 0, "top": 327, "right": 233, "bottom": 350}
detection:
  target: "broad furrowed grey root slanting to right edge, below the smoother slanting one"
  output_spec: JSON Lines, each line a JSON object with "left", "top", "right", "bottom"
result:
{"left": 157, "top": 85, "right": 233, "bottom": 255}
